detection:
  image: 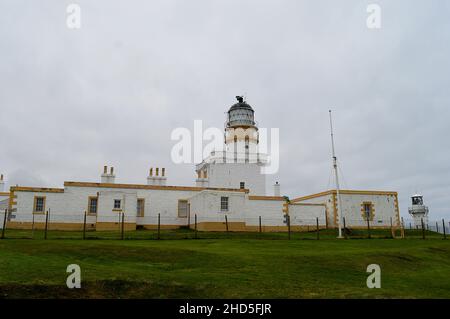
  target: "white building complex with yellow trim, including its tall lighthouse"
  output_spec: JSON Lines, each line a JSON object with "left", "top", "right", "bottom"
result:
{"left": 0, "top": 97, "right": 400, "bottom": 231}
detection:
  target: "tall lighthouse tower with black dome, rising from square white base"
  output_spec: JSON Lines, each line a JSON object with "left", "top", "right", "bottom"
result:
{"left": 196, "top": 96, "right": 267, "bottom": 195}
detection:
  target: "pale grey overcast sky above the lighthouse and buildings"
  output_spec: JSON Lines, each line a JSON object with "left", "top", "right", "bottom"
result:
{"left": 0, "top": 0, "right": 450, "bottom": 219}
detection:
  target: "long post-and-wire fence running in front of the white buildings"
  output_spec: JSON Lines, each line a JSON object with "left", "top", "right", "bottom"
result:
{"left": 0, "top": 211, "right": 450, "bottom": 240}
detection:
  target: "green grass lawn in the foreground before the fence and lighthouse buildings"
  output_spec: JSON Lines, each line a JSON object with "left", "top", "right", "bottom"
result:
{"left": 0, "top": 230, "right": 450, "bottom": 298}
